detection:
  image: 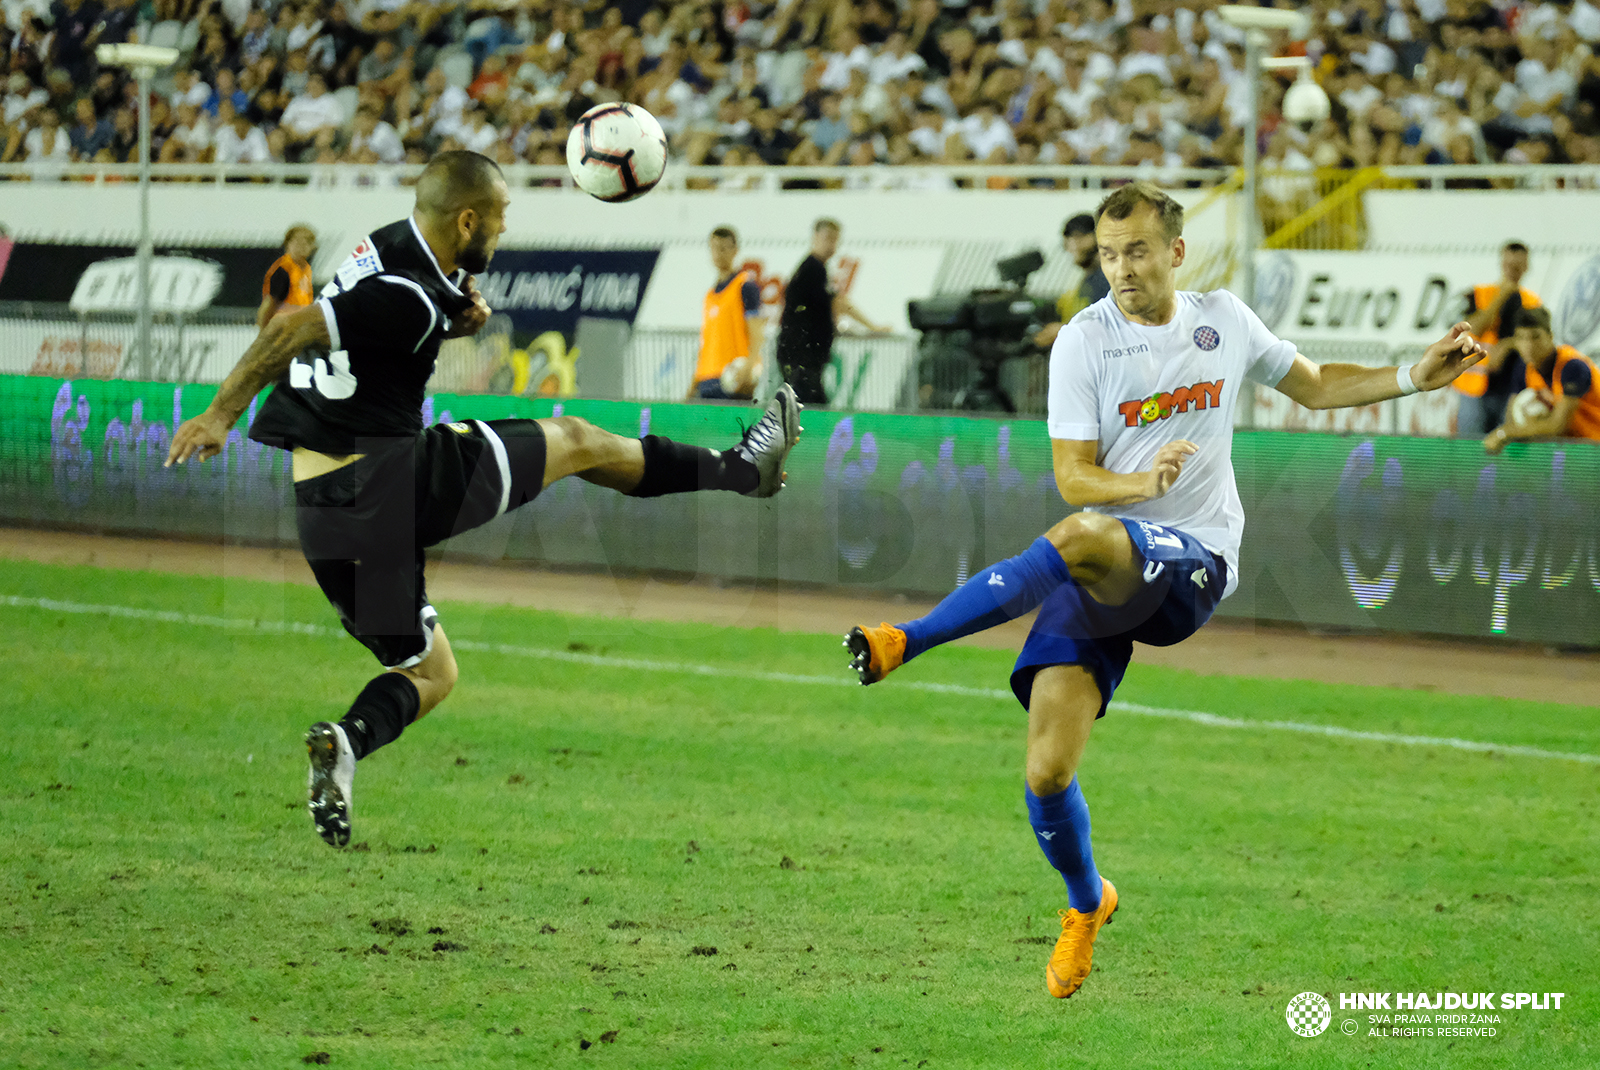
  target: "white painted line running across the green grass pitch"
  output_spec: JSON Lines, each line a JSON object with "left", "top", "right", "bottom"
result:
{"left": 0, "top": 595, "right": 1600, "bottom": 765}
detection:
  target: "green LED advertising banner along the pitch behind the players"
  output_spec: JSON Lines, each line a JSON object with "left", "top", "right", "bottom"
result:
{"left": 12, "top": 376, "right": 1600, "bottom": 648}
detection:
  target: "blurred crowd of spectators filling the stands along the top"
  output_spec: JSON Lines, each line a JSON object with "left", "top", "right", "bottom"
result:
{"left": 0, "top": 0, "right": 1600, "bottom": 184}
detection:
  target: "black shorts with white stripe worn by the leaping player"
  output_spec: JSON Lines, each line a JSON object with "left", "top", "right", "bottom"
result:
{"left": 294, "top": 419, "right": 546, "bottom": 669}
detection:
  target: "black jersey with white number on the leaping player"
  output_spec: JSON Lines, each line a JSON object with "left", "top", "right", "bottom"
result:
{"left": 250, "top": 219, "right": 472, "bottom": 454}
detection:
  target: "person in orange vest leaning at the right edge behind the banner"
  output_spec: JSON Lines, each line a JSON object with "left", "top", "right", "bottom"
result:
{"left": 1483, "top": 309, "right": 1600, "bottom": 453}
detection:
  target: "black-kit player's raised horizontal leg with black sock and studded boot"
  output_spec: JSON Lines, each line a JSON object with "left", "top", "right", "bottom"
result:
{"left": 537, "top": 384, "right": 803, "bottom": 504}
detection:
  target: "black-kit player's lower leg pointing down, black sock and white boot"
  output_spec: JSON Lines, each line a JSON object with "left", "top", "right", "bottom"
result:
{"left": 306, "top": 624, "right": 458, "bottom": 848}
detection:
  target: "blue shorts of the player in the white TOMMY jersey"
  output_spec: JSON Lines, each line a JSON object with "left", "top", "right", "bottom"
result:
{"left": 1011, "top": 520, "right": 1227, "bottom": 717}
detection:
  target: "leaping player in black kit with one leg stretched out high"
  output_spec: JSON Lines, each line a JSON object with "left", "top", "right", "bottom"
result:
{"left": 166, "top": 152, "right": 800, "bottom": 848}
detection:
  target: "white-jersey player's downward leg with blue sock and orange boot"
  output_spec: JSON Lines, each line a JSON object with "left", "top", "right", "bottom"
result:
{"left": 1026, "top": 665, "right": 1117, "bottom": 1000}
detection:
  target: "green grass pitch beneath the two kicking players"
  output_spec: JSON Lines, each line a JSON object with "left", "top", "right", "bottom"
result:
{"left": 0, "top": 561, "right": 1600, "bottom": 1070}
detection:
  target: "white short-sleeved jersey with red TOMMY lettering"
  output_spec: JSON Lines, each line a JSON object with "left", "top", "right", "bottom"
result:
{"left": 1050, "top": 289, "right": 1294, "bottom": 595}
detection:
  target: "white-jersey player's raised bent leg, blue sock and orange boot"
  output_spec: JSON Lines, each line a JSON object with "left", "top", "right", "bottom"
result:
{"left": 845, "top": 513, "right": 1141, "bottom": 683}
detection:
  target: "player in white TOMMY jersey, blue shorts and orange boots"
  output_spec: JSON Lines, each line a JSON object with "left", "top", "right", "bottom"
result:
{"left": 845, "top": 182, "right": 1485, "bottom": 996}
